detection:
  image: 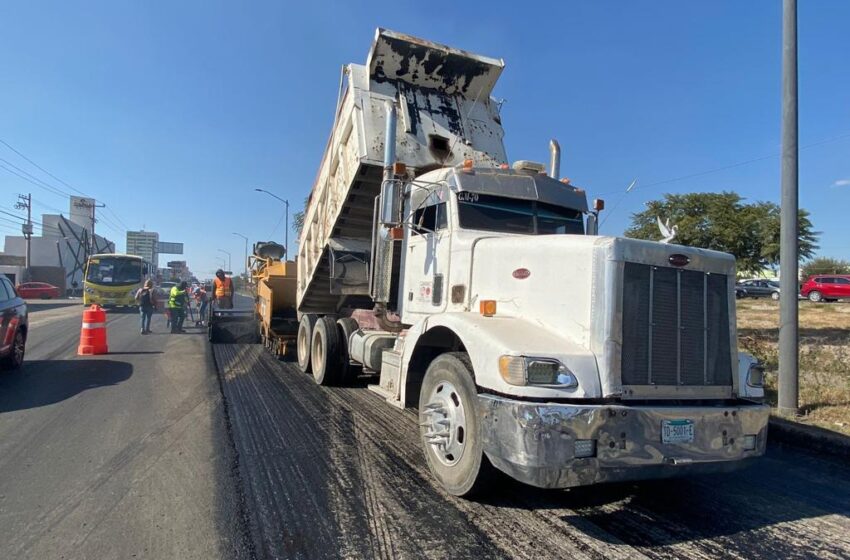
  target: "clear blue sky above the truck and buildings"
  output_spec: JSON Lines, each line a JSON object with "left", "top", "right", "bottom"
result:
{"left": 0, "top": 0, "right": 850, "bottom": 276}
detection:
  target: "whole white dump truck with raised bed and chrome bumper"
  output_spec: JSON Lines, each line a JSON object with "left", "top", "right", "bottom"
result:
{"left": 296, "top": 29, "right": 768, "bottom": 495}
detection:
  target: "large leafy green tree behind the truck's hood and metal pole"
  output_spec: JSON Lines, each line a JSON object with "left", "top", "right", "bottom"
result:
{"left": 626, "top": 192, "right": 818, "bottom": 273}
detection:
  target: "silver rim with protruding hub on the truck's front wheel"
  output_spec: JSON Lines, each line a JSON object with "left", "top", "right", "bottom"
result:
{"left": 419, "top": 381, "right": 467, "bottom": 466}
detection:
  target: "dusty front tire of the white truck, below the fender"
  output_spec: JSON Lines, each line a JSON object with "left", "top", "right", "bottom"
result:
{"left": 419, "top": 352, "right": 495, "bottom": 496}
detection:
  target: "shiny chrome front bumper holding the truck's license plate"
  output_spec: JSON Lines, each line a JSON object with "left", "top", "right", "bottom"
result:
{"left": 478, "top": 395, "right": 769, "bottom": 488}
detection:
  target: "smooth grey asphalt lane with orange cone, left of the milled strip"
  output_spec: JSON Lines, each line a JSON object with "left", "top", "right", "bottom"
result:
{"left": 0, "top": 300, "right": 250, "bottom": 560}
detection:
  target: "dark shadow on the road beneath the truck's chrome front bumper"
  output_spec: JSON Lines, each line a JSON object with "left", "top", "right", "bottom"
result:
{"left": 480, "top": 448, "right": 850, "bottom": 556}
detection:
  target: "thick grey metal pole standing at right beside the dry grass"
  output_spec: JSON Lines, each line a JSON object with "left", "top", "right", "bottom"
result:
{"left": 779, "top": 0, "right": 800, "bottom": 415}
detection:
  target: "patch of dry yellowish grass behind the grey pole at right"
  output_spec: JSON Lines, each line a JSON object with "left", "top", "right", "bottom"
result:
{"left": 738, "top": 300, "right": 850, "bottom": 434}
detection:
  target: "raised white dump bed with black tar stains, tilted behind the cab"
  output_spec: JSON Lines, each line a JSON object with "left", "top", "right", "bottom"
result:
{"left": 297, "top": 29, "right": 507, "bottom": 313}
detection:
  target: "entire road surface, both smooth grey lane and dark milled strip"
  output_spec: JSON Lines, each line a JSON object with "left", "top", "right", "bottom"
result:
{"left": 0, "top": 296, "right": 850, "bottom": 558}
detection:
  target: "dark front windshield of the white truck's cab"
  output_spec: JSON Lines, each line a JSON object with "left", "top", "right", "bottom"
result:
{"left": 458, "top": 192, "right": 584, "bottom": 235}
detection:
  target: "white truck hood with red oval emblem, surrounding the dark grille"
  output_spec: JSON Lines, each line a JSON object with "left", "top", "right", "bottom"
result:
{"left": 469, "top": 235, "right": 735, "bottom": 395}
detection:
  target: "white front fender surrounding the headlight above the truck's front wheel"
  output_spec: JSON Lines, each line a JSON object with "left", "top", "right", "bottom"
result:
{"left": 400, "top": 313, "right": 602, "bottom": 406}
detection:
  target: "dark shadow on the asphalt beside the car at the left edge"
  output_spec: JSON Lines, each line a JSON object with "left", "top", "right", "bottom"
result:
{"left": 0, "top": 359, "right": 133, "bottom": 413}
